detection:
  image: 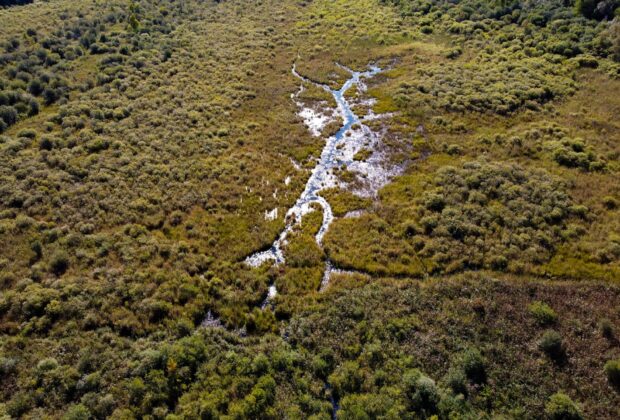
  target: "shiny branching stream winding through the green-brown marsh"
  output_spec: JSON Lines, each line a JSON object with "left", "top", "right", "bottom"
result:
{"left": 245, "top": 65, "right": 381, "bottom": 308}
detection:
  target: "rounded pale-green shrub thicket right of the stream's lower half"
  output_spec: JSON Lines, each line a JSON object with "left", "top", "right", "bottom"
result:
{"left": 419, "top": 162, "right": 571, "bottom": 270}
